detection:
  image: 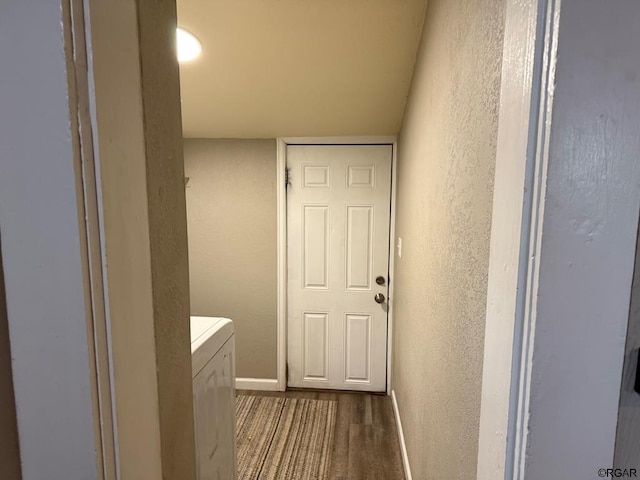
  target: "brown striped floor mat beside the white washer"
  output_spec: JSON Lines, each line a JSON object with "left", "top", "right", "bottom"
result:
{"left": 236, "top": 395, "right": 337, "bottom": 480}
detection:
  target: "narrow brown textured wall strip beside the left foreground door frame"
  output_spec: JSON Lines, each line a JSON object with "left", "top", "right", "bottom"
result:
{"left": 138, "top": 0, "right": 196, "bottom": 480}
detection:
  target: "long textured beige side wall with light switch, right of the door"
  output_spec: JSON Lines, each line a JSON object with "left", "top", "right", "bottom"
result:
{"left": 393, "top": 0, "right": 504, "bottom": 480}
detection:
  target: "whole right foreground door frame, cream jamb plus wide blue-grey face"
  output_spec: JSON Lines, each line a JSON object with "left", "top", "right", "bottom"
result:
{"left": 476, "top": 0, "right": 640, "bottom": 480}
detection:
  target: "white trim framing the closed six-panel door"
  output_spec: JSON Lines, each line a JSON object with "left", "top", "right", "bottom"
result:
{"left": 276, "top": 135, "right": 398, "bottom": 395}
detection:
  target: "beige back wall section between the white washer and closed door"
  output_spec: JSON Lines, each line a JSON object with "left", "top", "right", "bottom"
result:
{"left": 184, "top": 139, "right": 277, "bottom": 378}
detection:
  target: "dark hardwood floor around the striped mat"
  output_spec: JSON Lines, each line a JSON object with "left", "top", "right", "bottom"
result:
{"left": 237, "top": 390, "right": 404, "bottom": 480}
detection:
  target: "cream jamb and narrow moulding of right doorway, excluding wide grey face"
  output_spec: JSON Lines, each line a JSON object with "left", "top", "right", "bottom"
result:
{"left": 477, "top": 0, "right": 557, "bottom": 480}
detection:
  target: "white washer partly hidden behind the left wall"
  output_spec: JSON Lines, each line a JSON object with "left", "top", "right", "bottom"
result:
{"left": 191, "top": 317, "right": 237, "bottom": 480}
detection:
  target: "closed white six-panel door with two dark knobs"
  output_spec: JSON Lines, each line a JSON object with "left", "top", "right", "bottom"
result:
{"left": 287, "top": 145, "right": 392, "bottom": 391}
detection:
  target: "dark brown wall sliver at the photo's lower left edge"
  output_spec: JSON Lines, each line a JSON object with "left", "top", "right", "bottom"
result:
{"left": 0, "top": 246, "right": 22, "bottom": 480}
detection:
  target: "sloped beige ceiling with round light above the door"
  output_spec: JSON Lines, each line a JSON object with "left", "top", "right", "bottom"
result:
{"left": 178, "top": 0, "right": 426, "bottom": 138}
